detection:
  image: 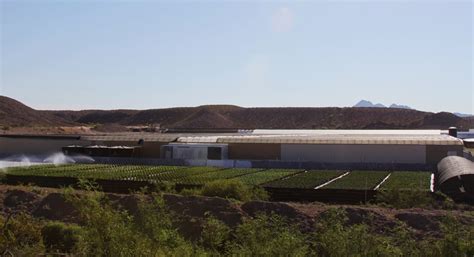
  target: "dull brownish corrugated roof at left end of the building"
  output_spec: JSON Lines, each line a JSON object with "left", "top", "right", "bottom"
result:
{"left": 81, "top": 134, "right": 178, "bottom": 142}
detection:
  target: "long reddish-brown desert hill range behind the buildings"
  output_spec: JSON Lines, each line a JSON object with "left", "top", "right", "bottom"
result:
{"left": 0, "top": 96, "right": 474, "bottom": 129}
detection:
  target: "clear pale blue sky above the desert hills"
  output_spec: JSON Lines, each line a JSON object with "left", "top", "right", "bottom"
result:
{"left": 0, "top": 0, "right": 474, "bottom": 113}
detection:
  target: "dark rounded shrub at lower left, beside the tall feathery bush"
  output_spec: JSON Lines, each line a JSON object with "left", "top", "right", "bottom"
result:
{"left": 41, "top": 222, "right": 82, "bottom": 253}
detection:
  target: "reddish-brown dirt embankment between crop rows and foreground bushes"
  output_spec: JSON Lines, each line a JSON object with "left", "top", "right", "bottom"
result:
{"left": 0, "top": 186, "right": 474, "bottom": 239}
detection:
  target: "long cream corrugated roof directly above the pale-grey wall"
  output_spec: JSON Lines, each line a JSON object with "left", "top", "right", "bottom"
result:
{"left": 217, "top": 134, "right": 463, "bottom": 145}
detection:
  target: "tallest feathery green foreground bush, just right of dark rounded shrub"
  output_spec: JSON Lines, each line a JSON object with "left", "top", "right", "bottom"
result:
{"left": 63, "top": 187, "right": 194, "bottom": 257}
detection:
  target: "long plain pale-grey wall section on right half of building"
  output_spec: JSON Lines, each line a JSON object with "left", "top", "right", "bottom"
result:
{"left": 281, "top": 144, "right": 426, "bottom": 164}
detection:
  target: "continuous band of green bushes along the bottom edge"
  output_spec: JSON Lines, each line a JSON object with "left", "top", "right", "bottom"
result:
{"left": 0, "top": 186, "right": 474, "bottom": 257}
